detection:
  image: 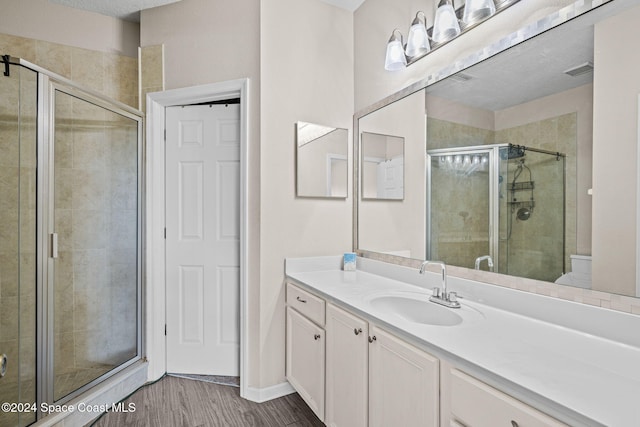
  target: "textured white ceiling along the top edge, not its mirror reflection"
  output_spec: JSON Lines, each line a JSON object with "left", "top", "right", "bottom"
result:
{"left": 49, "top": 0, "right": 364, "bottom": 22}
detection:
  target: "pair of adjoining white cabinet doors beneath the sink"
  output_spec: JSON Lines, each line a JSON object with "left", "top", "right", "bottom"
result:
{"left": 325, "top": 304, "right": 439, "bottom": 427}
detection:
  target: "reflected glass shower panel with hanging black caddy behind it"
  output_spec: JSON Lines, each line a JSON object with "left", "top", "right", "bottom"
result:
{"left": 499, "top": 147, "right": 566, "bottom": 282}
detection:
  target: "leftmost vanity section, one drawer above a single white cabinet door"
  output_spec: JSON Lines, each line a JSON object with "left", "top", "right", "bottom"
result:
{"left": 286, "top": 284, "right": 325, "bottom": 420}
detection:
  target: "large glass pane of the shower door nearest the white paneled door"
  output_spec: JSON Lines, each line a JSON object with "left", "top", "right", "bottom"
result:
{"left": 48, "top": 90, "right": 140, "bottom": 402}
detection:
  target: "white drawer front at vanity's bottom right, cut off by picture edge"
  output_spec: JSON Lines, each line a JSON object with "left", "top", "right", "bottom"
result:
{"left": 451, "top": 369, "right": 566, "bottom": 427}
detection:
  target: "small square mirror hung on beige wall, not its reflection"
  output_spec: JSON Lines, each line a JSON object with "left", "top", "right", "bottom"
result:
{"left": 296, "top": 122, "right": 349, "bottom": 199}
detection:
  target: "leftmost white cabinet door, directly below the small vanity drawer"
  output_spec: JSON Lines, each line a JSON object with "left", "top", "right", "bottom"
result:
{"left": 286, "top": 307, "right": 325, "bottom": 420}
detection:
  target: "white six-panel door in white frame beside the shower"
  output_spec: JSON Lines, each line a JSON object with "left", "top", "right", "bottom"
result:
{"left": 165, "top": 104, "right": 240, "bottom": 376}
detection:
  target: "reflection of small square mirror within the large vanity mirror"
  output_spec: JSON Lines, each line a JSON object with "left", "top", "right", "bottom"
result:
{"left": 360, "top": 132, "right": 404, "bottom": 200}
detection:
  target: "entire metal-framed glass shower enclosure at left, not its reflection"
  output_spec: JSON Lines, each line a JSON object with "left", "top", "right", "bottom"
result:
{"left": 0, "top": 56, "right": 143, "bottom": 426}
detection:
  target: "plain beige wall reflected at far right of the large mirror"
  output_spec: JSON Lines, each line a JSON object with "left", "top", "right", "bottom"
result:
{"left": 592, "top": 7, "right": 640, "bottom": 295}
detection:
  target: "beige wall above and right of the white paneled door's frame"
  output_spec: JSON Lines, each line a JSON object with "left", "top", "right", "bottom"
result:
{"left": 140, "top": 0, "right": 264, "bottom": 387}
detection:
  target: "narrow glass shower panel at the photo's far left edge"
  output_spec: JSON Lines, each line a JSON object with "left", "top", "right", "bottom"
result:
{"left": 0, "top": 61, "right": 37, "bottom": 427}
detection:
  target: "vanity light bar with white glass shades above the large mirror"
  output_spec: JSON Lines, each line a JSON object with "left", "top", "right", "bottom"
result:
{"left": 384, "top": 0, "right": 520, "bottom": 71}
